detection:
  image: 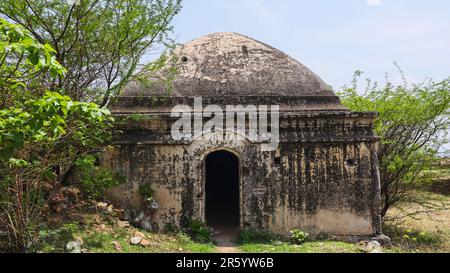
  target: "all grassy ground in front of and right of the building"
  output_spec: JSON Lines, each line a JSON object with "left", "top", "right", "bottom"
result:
{"left": 35, "top": 166, "right": 450, "bottom": 253}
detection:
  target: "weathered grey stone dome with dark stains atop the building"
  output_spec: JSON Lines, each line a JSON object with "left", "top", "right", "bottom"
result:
{"left": 112, "top": 32, "right": 349, "bottom": 113}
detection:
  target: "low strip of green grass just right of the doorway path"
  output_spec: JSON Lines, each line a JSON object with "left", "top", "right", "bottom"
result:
{"left": 239, "top": 241, "right": 362, "bottom": 253}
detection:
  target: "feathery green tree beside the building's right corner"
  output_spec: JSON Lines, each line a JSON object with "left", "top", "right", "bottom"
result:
{"left": 338, "top": 71, "right": 450, "bottom": 217}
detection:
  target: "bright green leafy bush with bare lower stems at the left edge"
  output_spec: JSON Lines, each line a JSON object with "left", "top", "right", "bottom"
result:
{"left": 0, "top": 19, "right": 112, "bottom": 251}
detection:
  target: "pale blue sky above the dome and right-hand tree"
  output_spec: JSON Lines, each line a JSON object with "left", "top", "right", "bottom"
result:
{"left": 174, "top": 0, "right": 450, "bottom": 89}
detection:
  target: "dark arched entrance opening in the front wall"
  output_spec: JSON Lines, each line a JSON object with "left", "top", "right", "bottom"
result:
{"left": 205, "top": 151, "right": 239, "bottom": 230}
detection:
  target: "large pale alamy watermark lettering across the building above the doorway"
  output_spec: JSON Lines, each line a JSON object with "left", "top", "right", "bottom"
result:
{"left": 171, "top": 97, "right": 280, "bottom": 151}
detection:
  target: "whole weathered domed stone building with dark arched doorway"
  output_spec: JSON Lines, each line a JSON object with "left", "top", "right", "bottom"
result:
{"left": 103, "top": 33, "right": 381, "bottom": 235}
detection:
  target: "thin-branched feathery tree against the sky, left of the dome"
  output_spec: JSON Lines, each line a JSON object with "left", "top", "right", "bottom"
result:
{"left": 0, "top": 0, "right": 181, "bottom": 106}
